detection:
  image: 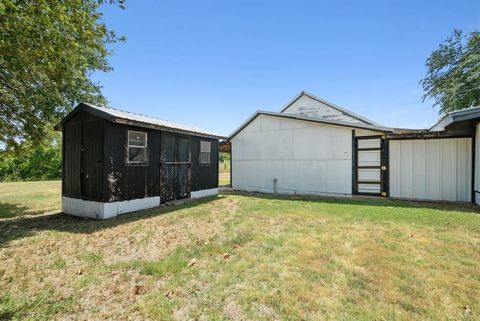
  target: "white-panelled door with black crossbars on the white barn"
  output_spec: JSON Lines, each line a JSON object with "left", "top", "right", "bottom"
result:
{"left": 353, "top": 136, "right": 388, "bottom": 196}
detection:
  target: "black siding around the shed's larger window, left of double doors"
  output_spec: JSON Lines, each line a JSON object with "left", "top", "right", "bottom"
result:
{"left": 104, "top": 121, "right": 160, "bottom": 202}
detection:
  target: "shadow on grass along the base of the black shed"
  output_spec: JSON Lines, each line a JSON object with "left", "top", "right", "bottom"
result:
{"left": 0, "top": 196, "right": 220, "bottom": 247}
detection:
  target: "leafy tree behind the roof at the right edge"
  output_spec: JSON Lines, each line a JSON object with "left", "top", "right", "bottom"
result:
{"left": 420, "top": 30, "right": 480, "bottom": 113}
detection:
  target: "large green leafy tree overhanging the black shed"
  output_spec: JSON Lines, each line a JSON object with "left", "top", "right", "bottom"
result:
{"left": 0, "top": 0, "right": 124, "bottom": 149}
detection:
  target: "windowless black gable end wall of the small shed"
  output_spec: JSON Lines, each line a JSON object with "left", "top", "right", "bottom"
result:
{"left": 62, "top": 112, "right": 104, "bottom": 201}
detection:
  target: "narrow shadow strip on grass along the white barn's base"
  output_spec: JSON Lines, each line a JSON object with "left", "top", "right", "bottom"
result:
{"left": 222, "top": 191, "right": 480, "bottom": 214}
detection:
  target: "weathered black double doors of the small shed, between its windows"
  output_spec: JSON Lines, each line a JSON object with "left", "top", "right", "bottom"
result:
{"left": 160, "top": 133, "right": 192, "bottom": 203}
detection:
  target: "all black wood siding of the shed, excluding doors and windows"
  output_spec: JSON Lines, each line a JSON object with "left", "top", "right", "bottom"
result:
{"left": 62, "top": 111, "right": 218, "bottom": 202}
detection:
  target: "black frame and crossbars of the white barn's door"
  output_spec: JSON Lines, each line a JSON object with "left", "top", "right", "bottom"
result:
{"left": 352, "top": 130, "right": 390, "bottom": 197}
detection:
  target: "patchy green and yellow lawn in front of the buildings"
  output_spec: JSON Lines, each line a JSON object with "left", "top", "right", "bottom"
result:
{"left": 0, "top": 182, "right": 480, "bottom": 320}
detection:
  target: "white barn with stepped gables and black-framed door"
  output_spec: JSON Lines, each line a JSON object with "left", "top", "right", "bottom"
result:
{"left": 229, "top": 92, "right": 480, "bottom": 203}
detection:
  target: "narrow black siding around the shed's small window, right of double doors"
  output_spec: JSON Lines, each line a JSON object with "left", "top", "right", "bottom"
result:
{"left": 191, "top": 136, "right": 218, "bottom": 191}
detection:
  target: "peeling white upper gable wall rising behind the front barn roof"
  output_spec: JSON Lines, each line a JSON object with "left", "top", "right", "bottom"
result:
{"left": 283, "top": 95, "right": 364, "bottom": 124}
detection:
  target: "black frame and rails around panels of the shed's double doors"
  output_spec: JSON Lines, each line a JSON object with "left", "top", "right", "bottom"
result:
{"left": 160, "top": 132, "right": 192, "bottom": 203}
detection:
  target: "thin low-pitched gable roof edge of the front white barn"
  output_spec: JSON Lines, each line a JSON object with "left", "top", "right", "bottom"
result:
{"left": 228, "top": 110, "right": 393, "bottom": 140}
